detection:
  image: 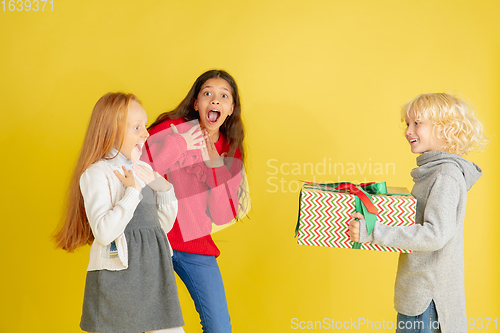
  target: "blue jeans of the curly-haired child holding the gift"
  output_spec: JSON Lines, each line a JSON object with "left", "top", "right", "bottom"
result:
{"left": 396, "top": 301, "right": 441, "bottom": 333}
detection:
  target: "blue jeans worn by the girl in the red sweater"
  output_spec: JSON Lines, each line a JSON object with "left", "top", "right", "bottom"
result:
{"left": 172, "top": 250, "right": 231, "bottom": 333}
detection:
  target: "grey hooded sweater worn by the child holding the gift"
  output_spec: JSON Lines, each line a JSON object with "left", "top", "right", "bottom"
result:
{"left": 360, "top": 151, "right": 482, "bottom": 333}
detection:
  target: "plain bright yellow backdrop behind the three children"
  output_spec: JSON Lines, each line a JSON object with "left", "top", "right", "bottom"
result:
{"left": 0, "top": 0, "right": 500, "bottom": 333}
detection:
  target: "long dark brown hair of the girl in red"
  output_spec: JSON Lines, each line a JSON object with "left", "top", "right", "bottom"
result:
{"left": 148, "top": 69, "right": 245, "bottom": 162}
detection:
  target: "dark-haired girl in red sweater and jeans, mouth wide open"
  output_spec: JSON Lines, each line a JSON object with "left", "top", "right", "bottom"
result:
{"left": 143, "top": 70, "right": 249, "bottom": 333}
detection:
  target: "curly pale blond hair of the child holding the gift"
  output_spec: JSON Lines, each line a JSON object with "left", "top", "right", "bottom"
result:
{"left": 401, "top": 93, "right": 488, "bottom": 155}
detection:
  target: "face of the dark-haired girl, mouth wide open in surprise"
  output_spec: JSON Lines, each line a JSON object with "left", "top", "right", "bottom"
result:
{"left": 194, "top": 78, "right": 234, "bottom": 141}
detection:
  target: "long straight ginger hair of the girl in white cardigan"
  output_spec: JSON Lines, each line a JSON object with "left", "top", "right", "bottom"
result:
{"left": 54, "top": 93, "right": 140, "bottom": 252}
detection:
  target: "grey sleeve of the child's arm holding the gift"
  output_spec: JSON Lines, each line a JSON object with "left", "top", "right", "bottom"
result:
{"left": 360, "top": 175, "right": 466, "bottom": 251}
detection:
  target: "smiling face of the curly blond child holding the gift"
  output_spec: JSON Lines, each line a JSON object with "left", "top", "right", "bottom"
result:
{"left": 405, "top": 112, "right": 444, "bottom": 154}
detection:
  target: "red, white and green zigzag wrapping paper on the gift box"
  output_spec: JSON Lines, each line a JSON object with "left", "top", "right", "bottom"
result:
{"left": 297, "top": 184, "right": 417, "bottom": 253}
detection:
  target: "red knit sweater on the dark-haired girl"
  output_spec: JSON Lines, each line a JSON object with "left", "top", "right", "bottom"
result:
{"left": 142, "top": 119, "right": 242, "bottom": 257}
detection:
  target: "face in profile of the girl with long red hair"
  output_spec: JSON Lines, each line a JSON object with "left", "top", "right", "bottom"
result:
{"left": 120, "top": 101, "right": 149, "bottom": 162}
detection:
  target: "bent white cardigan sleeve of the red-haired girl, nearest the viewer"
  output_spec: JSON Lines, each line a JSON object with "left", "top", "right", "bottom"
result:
{"left": 80, "top": 167, "right": 142, "bottom": 246}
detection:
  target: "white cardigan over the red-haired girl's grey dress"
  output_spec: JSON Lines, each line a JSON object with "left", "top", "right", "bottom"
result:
{"left": 80, "top": 150, "right": 178, "bottom": 271}
